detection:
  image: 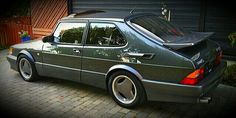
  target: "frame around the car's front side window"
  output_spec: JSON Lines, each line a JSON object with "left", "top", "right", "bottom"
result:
{"left": 51, "top": 20, "right": 88, "bottom": 46}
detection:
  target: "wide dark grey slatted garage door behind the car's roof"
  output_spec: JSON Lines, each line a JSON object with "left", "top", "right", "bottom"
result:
{"left": 72, "top": 0, "right": 201, "bottom": 31}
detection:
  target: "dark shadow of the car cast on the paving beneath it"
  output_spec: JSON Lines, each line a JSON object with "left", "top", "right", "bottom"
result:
{"left": 33, "top": 77, "right": 236, "bottom": 118}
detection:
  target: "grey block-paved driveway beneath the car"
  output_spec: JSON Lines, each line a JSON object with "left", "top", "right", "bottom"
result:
{"left": 0, "top": 50, "right": 236, "bottom": 118}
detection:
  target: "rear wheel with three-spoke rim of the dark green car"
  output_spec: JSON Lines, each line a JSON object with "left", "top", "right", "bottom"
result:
{"left": 108, "top": 71, "right": 146, "bottom": 108}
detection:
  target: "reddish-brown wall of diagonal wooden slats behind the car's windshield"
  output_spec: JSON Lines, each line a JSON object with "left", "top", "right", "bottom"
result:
{"left": 31, "top": 0, "right": 68, "bottom": 38}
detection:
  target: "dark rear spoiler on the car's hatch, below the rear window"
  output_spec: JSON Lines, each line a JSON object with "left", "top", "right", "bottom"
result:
{"left": 163, "top": 32, "right": 214, "bottom": 50}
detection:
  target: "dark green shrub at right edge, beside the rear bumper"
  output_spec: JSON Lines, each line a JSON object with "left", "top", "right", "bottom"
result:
{"left": 222, "top": 64, "right": 236, "bottom": 87}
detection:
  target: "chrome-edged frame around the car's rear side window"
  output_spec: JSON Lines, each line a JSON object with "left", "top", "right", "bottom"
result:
{"left": 83, "top": 21, "right": 128, "bottom": 48}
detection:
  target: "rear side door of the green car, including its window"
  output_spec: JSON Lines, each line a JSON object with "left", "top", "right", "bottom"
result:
{"left": 81, "top": 22, "right": 127, "bottom": 88}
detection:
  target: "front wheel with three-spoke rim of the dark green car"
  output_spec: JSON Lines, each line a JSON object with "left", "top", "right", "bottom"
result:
{"left": 17, "top": 54, "right": 38, "bottom": 82}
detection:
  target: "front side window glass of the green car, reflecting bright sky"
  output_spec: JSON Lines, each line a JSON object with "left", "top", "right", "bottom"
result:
{"left": 53, "top": 23, "right": 86, "bottom": 44}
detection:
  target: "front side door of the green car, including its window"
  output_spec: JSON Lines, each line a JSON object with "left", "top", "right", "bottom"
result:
{"left": 42, "top": 22, "right": 87, "bottom": 81}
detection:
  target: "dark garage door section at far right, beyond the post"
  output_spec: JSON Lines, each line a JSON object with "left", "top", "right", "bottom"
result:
{"left": 205, "top": 1, "right": 236, "bottom": 55}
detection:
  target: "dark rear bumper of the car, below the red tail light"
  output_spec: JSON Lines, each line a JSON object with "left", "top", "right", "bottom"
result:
{"left": 142, "top": 61, "right": 226, "bottom": 103}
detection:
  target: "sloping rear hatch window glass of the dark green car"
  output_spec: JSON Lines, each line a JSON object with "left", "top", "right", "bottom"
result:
{"left": 130, "top": 15, "right": 190, "bottom": 42}
